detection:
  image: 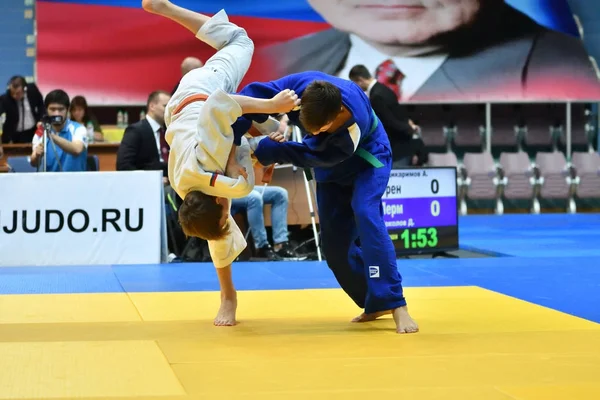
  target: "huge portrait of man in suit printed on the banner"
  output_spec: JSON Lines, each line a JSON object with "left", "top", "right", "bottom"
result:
{"left": 261, "top": 0, "right": 600, "bottom": 101}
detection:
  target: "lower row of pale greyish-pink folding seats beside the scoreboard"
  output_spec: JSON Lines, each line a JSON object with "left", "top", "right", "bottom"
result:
{"left": 429, "top": 151, "right": 600, "bottom": 215}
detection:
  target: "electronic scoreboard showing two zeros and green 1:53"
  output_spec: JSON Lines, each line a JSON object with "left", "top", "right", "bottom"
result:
{"left": 383, "top": 167, "right": 458, "bottom": 255}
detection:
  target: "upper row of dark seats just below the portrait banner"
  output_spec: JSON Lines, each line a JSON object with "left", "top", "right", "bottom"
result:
{"left": 410, "top": 104, "right": 598, "bottom": 155}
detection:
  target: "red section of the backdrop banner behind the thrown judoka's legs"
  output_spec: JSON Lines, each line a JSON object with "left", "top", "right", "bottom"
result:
{"left": 37, "top": 2, "right": 328, "bottom": 105}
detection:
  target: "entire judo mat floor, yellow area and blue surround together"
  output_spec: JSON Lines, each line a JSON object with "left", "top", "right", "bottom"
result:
{"left": 0, "top": 214, "right": 600, "bottom": 400}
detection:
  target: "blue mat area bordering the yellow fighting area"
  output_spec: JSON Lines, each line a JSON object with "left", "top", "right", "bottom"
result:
{"left": 0, "top": 214, "right": 600, "bottom": 323}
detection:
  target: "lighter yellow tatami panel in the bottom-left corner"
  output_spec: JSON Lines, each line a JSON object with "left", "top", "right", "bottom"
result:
{"left": 0, "top": 341, "right": 185, "bottom": 399}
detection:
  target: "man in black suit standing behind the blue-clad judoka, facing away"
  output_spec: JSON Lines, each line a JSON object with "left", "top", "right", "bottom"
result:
{"left": 348, "top": 65, "right": 418, "bottom": 168}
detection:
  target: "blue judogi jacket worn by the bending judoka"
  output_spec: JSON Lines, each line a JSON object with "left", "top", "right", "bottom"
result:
{"left": 233, "top": 71, "right": 391, "bottom": 183}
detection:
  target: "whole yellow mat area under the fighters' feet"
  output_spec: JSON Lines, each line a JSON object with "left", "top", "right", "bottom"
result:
{"left": 0, "top": 287, "right": 600, "bottom": 400}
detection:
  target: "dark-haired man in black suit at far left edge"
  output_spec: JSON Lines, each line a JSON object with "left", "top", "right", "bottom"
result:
{"left": 0, "top": 76, "right": 44, "bottom": 143}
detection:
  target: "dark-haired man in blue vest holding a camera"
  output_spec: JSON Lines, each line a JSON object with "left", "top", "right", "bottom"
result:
{"left": 31, "top": 89, "right": 88, "bottom": 172}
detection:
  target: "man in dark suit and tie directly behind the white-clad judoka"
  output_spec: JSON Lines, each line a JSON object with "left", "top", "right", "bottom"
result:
{"left": 117, "top": 90, "right": 171, "bottom": 183}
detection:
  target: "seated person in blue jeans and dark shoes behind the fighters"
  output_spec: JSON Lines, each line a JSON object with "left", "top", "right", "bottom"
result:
{"left": 231, "top": 164, "right": 306, "bottom": 261}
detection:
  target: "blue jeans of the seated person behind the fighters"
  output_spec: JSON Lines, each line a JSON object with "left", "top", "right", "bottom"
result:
{"left": 231, "top": 186, "right": 288, "bottom": 249}
